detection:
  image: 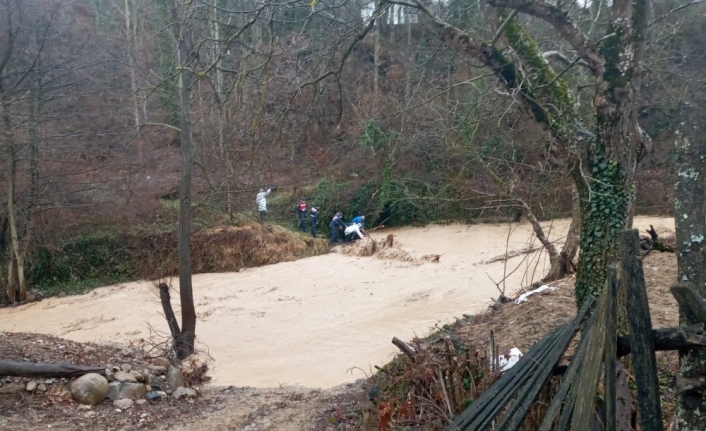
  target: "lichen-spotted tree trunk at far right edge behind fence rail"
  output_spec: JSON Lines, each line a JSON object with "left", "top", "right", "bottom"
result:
{"left": 674, "top": 103, "right": 706, "bottom": 430}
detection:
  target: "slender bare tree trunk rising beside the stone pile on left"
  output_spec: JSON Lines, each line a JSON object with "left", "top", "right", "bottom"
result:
{"left": 170, "top": 3, "right": 196, "bottom": 359}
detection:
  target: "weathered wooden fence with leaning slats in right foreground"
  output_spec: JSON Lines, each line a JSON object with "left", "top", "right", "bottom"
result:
{"left": 446, "top": 230, "right": 706, "bottom": 431}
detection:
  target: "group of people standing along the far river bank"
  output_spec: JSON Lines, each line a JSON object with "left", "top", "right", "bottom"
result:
{"left": 255, "top": 187, "right": 365, "bottom": 244}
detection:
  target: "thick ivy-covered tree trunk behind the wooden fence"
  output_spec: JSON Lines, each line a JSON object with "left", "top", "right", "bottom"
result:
{"left": 575, "top": 0, "right": 650, "bottom": 306}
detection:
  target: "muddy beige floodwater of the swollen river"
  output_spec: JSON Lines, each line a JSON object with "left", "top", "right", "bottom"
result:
{"left": 0, "top": 217, "right": 674, "bottom": 388}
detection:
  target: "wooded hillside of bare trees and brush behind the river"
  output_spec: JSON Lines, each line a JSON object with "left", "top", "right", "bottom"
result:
{"left": 0, "top": 0, "right": 706, "bottom": 300}
